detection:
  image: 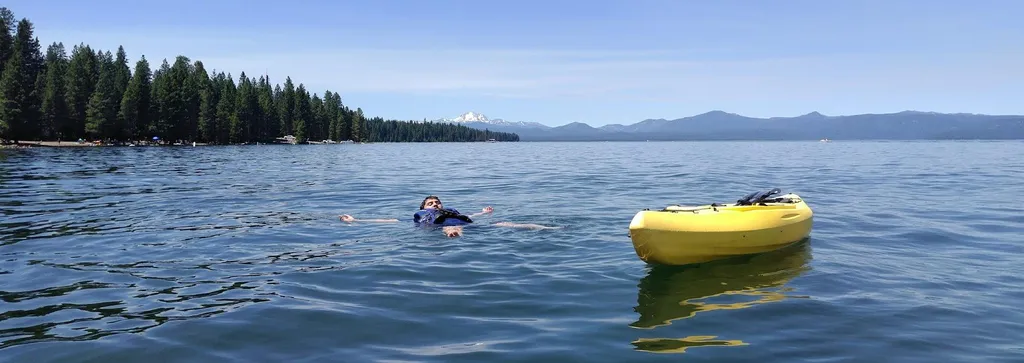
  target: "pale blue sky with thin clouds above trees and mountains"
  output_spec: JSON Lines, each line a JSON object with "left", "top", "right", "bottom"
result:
{"left": 4, "top": 0, "right": 1024, "bottom": 126}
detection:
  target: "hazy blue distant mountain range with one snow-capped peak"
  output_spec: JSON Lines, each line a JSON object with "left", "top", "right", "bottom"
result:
{"left": 425, "top": 111, "right": 1024, "bottom": 142}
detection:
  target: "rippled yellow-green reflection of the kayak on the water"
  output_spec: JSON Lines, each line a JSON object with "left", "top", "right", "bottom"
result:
{"left": 630, "top": 240, "right": 811, "bottom": 353}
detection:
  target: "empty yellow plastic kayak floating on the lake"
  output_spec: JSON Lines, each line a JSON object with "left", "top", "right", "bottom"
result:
{"left": 630, "top": 189, "right": 813, "bottom": 265}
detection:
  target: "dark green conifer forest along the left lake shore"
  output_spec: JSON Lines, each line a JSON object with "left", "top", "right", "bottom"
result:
{"left": 0, "top": 7, "right": 519, "bottom": 145}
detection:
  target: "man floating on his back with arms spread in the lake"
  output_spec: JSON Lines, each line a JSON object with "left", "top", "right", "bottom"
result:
{"left": 341, "top": 196, "right": 558, "bottom": 237}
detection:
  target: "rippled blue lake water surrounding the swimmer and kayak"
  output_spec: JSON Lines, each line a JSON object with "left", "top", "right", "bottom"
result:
{"left": 0, "top": 142, "right": 1024, "bottom": 363}
